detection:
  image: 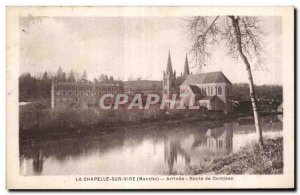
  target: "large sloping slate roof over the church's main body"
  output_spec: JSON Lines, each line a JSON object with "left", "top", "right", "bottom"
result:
{"left": 182, "top": 71, "right": 231, "bottom": 85}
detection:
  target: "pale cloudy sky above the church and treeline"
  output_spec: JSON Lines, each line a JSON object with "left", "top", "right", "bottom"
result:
{"left": 20, "top": 16, "right": 282, "bottom": 85}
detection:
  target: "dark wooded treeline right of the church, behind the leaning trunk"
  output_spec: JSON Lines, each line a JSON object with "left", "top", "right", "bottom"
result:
{"left": 232, "top": 83, "right": 282, "bottom": 102}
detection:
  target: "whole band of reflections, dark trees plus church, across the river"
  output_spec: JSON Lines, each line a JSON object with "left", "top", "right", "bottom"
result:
{"left": 20, "top": 116, "right": 282, "bottom": 174}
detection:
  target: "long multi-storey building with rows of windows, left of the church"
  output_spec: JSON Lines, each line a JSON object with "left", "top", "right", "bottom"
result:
{"left": 51, "top": 81, "right": 124, "bottom": 108}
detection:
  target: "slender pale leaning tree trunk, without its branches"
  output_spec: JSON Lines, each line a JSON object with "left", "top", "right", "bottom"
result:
{"left": 229, "top": 16, "right": 264, "bottom": 148}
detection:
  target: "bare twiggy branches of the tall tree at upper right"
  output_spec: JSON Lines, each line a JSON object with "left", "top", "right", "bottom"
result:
{"left": 187, "top": 16, "right": 264, "bottom": 68}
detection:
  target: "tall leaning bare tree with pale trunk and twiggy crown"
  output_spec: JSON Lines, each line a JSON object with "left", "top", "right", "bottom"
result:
{"left": 188, "top": 16, "right": 264, "bottom": 148}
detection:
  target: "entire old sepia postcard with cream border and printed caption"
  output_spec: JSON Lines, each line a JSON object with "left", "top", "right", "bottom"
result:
{"left": 6, "top": 7, "right": 295, "bottom": 189}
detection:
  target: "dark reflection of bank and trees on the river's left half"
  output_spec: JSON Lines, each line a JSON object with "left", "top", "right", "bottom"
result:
{"left": 20, "top": 125, "right": 161, "bottom": 173}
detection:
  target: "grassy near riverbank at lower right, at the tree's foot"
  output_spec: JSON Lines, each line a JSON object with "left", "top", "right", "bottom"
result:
{"left": 186, "top": 137, "right": 283, "bottom": 175}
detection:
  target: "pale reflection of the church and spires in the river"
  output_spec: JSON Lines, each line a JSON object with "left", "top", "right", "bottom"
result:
{"left": 164, "top": 123, "right": 233, "bottom": 174}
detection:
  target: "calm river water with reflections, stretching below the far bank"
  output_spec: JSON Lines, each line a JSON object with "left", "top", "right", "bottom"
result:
{"left": 20, "top": 116, "right": 282, "bottom": 175}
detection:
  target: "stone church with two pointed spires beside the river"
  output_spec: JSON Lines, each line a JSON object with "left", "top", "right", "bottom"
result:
{"left": 163, "top": 52, "right": 232, "bottom": 114}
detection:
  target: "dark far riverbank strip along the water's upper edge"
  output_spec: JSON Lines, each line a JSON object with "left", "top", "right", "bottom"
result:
{"left": 20, "top": 109, "right": 282, "bottom": 144}
